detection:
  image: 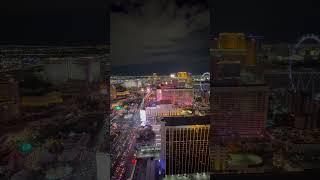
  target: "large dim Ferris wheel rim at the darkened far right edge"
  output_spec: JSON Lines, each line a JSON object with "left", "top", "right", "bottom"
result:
{"left": 288, "top": 34, "right": 320, "bottom": 91}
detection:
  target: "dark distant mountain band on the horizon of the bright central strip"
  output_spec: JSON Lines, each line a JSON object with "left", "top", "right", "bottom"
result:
{"left": 111, "top": 58, "right": 210, "bottom": 75}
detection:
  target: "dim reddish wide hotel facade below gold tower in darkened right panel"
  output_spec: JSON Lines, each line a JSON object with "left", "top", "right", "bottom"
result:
{"left": 211, "top": 86, "right": 267, "bottom": 138}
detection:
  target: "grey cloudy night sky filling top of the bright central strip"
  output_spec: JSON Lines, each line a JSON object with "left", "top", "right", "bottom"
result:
{"left": 110, "top": 0, "right": 209, "bottom": 68}
